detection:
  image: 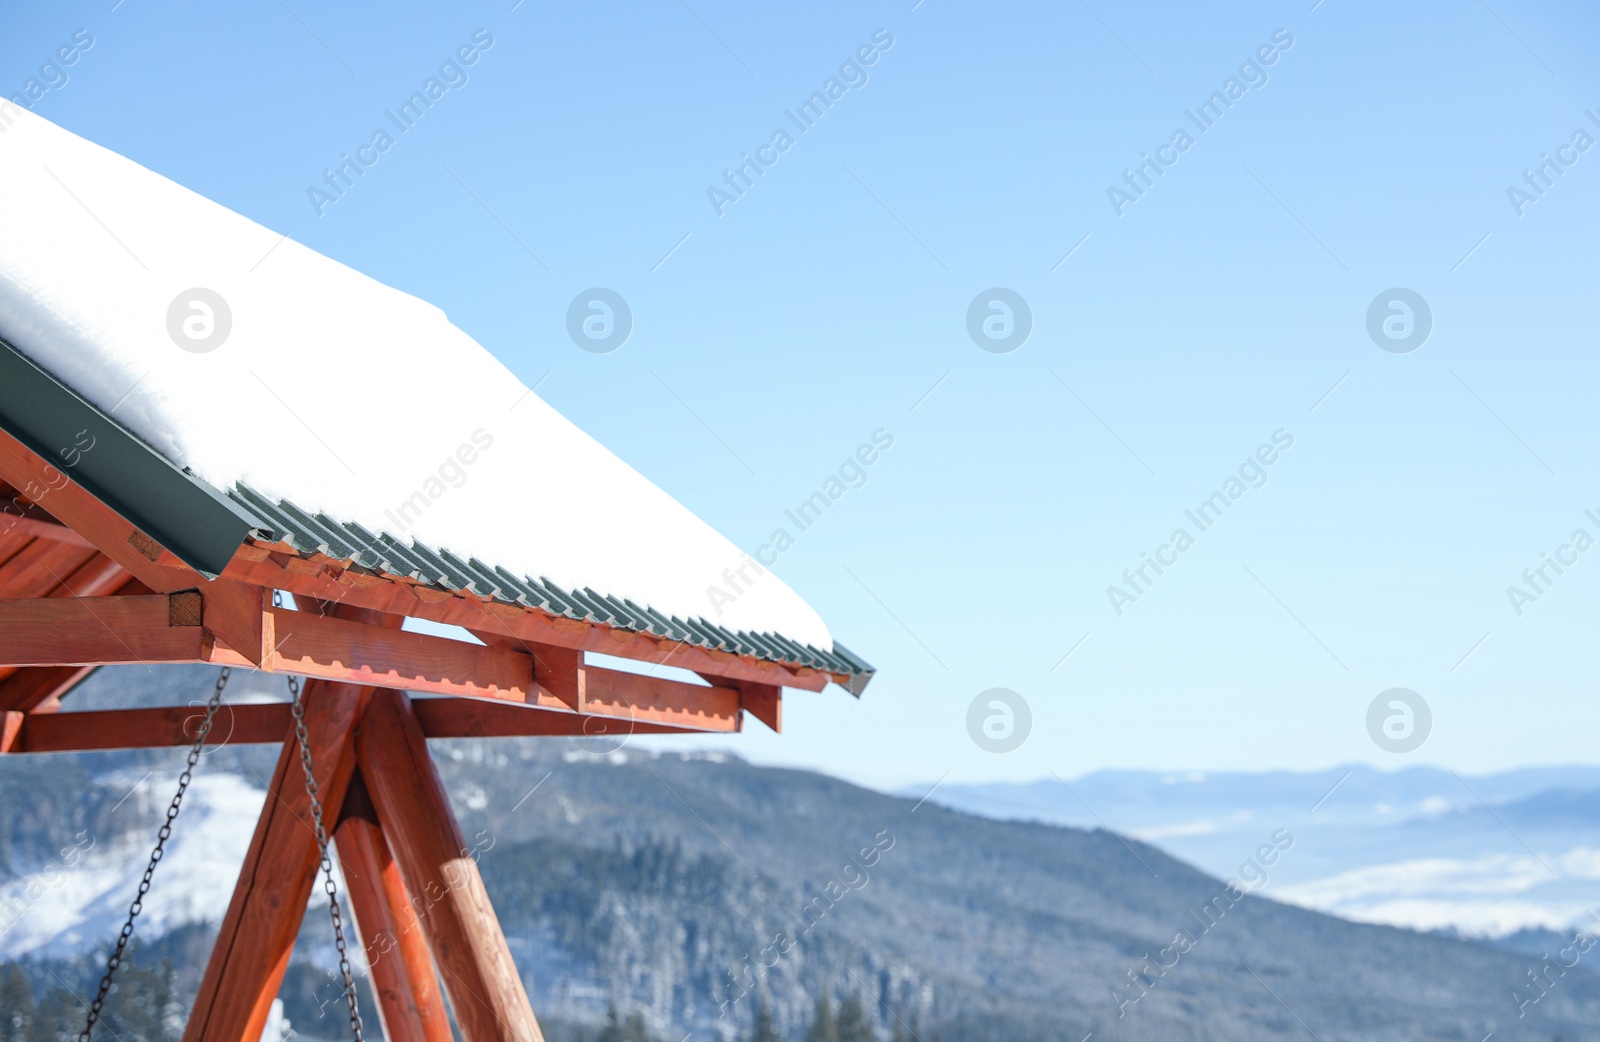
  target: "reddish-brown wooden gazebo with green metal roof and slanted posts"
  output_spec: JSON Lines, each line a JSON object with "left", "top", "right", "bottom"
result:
{"left": 0, "top": 104, "right": 872, "bottom": 1042}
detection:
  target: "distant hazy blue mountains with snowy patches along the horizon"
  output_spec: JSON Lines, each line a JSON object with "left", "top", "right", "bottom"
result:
{"left": 921, "top": 767, "right": 1600, "bottom": 938}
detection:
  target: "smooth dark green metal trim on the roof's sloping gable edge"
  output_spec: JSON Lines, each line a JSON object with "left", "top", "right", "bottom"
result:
{"left": 0, "top": 338, "right": 262, "bottom": 578}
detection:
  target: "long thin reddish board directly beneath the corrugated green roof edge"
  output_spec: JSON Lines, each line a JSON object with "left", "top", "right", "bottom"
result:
{"left": 224, "top": 543, "right": 834, "bottom": 691}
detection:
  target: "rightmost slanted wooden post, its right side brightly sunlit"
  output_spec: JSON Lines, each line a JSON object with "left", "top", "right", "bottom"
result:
{"left": 355, "top": 688, "right": 544, "bottom": 1042}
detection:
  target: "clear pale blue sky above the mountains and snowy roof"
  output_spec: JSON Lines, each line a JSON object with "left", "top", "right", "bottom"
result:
{"left": 12, "top": 0, "right": 1600, "bottom": 784}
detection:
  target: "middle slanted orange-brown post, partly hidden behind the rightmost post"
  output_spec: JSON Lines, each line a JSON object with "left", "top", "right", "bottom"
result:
{"left": 334, "top": 775, "right": 451, "bottom": 1042}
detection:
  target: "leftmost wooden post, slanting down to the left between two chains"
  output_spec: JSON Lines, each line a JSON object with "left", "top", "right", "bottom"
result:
{"left": 182, "top": 680, "right": 370, "bottom": 1042}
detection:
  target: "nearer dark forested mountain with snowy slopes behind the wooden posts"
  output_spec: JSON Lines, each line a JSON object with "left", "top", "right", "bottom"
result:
{"left": 0, "top": 667, "right": 1600, "bottom": 1042}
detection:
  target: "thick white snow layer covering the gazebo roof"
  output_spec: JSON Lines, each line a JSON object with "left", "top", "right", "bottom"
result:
{"left": 0, "top": 106, "right": 834, "bottom": 650}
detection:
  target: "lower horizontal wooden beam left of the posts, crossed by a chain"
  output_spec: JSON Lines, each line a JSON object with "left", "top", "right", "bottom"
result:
{"left": 11, "top": 703, "right": 290, "bottom": 752}
